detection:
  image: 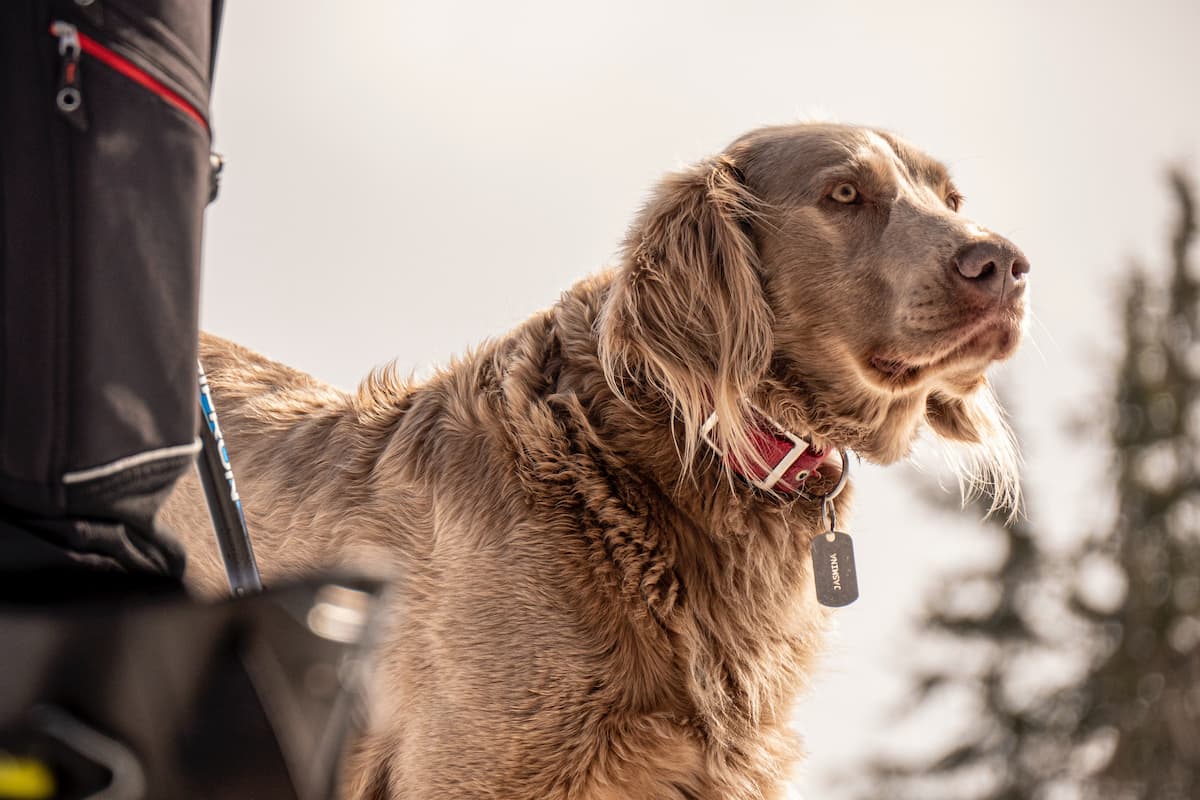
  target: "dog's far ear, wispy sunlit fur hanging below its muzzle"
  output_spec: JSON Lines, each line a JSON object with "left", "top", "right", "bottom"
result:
{"left": 925, "top": 383, "right": 1021, "bottom": 518}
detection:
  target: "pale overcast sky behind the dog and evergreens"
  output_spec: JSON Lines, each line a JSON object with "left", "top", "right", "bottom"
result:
{"left": 203, "top": 0, "right": 1200, "bottom": 796}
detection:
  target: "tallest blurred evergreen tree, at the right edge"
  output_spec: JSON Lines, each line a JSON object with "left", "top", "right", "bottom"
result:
{"left": 1079, "top": 173, "right": 1200, "bottom": 800}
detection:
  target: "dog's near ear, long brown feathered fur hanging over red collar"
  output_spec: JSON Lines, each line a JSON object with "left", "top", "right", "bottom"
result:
{"left": 599, "top": 157, "right": 772, "bottom": 474}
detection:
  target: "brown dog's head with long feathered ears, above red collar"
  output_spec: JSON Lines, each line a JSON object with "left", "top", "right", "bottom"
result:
{"left": 599, "top": 124, "right": 1030, "bottom": 503}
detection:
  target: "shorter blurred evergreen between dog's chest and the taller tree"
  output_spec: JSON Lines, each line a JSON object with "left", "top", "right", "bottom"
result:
{"left": 852, "top": 472, "right": 1079, "bottom": 800}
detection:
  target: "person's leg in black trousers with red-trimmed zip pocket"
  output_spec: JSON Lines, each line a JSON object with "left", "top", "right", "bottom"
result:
{"left": 0, "top": 0, "right": 220, "bottom": 582}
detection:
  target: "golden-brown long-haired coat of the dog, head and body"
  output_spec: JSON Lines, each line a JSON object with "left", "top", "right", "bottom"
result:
{"left": 167, "top": 125, "right": 1024, "bottom": 800}
